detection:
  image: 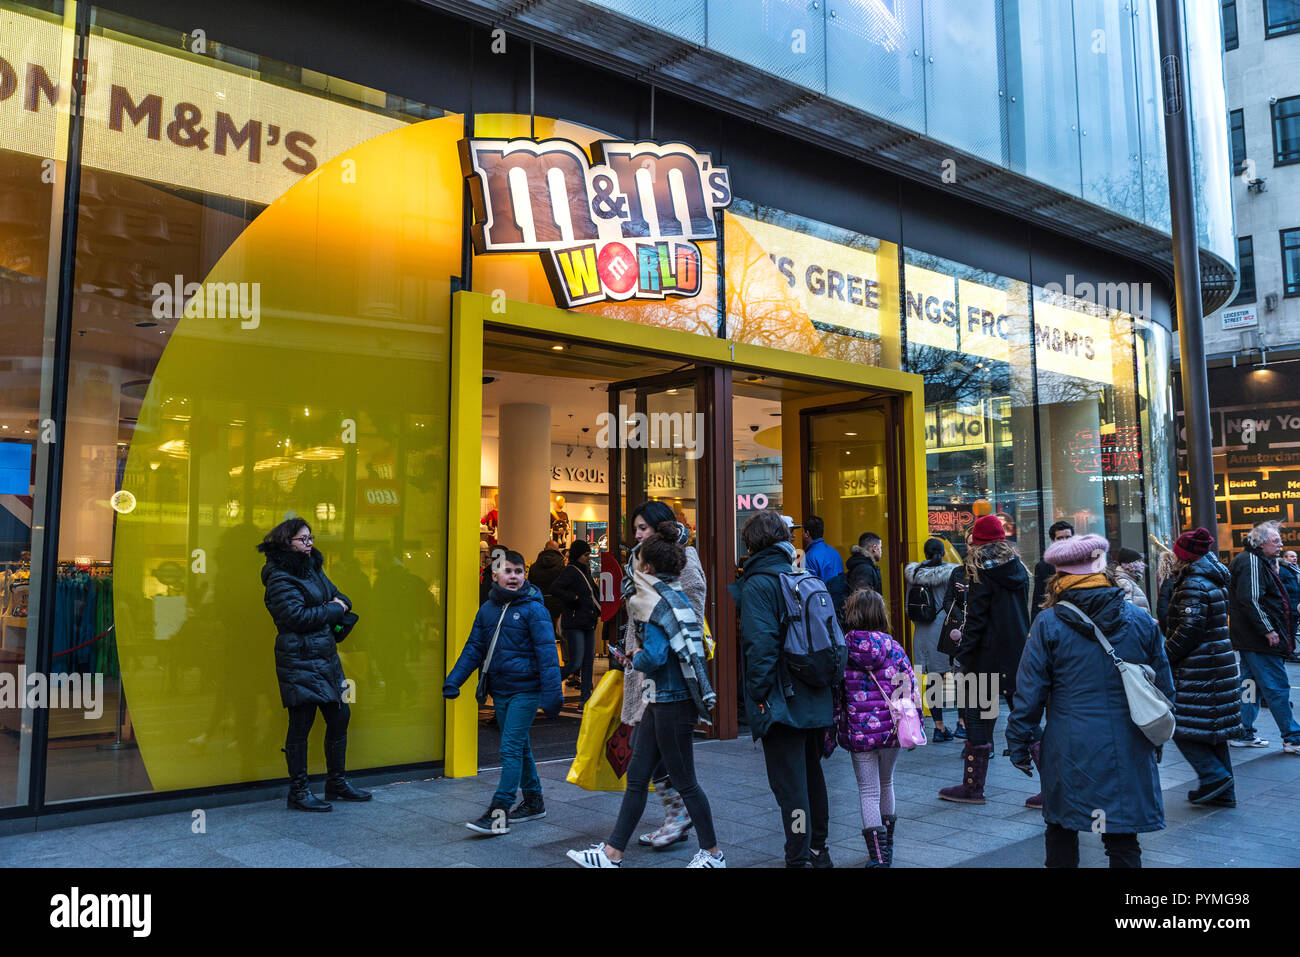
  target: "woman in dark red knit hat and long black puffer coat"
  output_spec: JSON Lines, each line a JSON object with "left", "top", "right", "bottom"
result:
{"left": 1160, "top": 528, "right": 1242, "bottom": 807}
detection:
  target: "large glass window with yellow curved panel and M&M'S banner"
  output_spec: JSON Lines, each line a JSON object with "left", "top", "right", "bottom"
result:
{"left": 46, "top": 9, "right": 464, "bottom": 802}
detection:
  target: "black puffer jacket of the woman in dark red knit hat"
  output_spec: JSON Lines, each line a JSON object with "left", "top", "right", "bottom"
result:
{"left": 1160, "top": 555, "right": 1242, "bottom": 744}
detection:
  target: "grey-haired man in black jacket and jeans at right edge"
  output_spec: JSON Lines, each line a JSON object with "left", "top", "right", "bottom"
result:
{"left": 1229, "top": 521, "right": 1300, "bottom": 754}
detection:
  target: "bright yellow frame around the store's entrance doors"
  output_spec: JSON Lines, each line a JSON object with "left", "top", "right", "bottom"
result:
{"left": 443, "top": 291, "right": 928, "bottom": 778}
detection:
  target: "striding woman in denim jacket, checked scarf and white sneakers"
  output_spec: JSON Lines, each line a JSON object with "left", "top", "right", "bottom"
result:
{"left": 568, "top": 521, "right": 727, "bottom": 869}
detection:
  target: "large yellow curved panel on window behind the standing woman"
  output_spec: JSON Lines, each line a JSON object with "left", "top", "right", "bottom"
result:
{"left": 113, "top": 116, "right": 463, "bottom": 791}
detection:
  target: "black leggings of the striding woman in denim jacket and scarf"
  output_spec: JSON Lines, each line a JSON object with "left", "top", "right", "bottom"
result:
{"left": 606, "top": 698, "right": 718, "bottom": 852}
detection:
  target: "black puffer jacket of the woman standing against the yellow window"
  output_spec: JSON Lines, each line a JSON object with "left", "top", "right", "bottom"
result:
{"left": 257, "top": 545, "right": 352, "bottom": 707}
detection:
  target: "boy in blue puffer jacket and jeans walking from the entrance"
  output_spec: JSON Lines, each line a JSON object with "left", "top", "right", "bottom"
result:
{"left": 442, "top": 551, "right": 564, "bottom": 836}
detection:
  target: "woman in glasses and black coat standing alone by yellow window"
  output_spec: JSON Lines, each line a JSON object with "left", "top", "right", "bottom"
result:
{"left": 257, "top": 519, "right": 371, "bottom": 811}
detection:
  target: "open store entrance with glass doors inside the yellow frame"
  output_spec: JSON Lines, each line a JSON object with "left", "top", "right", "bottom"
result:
{"left": 462, "top": 322, "right": 922, "bottom": 768}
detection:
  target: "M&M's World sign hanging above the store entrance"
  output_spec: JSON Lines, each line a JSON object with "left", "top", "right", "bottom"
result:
{"left": 460, "top": 139, "right": 732, "bottom": 307}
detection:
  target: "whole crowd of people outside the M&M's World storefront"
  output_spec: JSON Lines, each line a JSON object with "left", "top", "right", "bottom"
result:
{"left": 261, "top": 501, "right": 1300, "bottom": 869}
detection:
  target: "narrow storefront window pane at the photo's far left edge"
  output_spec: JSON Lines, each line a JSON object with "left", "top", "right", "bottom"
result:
{"left": 0, "top": 3, "right": 72, "bottom": 807}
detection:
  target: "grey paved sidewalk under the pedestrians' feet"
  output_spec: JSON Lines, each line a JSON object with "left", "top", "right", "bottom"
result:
{"left": 0, "top": 681, "right": 1300, "bottom": 867}
